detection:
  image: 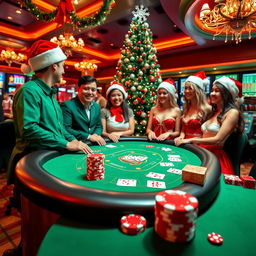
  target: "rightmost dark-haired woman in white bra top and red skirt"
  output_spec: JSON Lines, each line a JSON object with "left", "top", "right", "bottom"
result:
{"left": 176, "top": 76, "right": 243, "bottom": 174}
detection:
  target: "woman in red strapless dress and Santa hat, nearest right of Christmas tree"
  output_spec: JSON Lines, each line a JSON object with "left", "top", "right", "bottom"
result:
{"left": 147, "top": 79, "right": 181, "bottom": 141}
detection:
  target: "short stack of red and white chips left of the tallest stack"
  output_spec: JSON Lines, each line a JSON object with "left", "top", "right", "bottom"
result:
{"left": 120, "top": 214, "right": 147, "bottom": 235}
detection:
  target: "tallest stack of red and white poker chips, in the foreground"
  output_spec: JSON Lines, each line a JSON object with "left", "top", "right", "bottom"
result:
{"left": 155, "top": 190, "right": 198, "bottom": 242}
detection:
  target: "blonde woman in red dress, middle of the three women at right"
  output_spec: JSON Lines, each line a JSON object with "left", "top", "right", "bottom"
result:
{"left": 175, "top": 71, "right": 212, "bottom": 143}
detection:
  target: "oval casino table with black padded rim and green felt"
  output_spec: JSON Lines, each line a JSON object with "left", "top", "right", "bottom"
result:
{"left": 16, "top": 137, "right": 220, "bottom": 255}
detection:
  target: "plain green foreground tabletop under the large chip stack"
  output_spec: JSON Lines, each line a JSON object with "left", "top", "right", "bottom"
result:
{"left": 38, "top": 177, "right": 256, "bottom": 256}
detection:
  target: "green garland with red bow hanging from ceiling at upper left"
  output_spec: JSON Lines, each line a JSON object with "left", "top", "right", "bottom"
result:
{"left": 20, "top": 0, "right": 115, "bottom": 28}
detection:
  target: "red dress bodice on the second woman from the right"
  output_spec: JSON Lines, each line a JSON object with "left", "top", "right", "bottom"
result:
{"left": 181, "top": 118, "right": 203, "bottom": 139}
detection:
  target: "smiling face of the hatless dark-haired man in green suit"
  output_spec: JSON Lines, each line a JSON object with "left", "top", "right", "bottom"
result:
{"left": 77, "top": 82, "right": 97, "bottom": 104}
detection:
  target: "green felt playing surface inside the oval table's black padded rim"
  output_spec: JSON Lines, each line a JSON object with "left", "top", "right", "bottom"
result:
{"left": 43, "top": 141, "right": 202, "bottom": 192}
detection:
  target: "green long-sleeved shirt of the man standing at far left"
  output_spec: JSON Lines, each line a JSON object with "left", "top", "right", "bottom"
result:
{"left": 7, "top": 78, "right": 75, "bottom": 183}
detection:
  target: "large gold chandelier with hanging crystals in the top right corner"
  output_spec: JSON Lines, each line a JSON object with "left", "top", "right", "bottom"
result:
{"left": 200, "top": 0, "right": 256, "bottom": 44}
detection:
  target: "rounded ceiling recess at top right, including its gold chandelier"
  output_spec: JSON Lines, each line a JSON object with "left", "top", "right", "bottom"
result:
{"left": 179, "top": 0, "right": 256, "bottom": 43}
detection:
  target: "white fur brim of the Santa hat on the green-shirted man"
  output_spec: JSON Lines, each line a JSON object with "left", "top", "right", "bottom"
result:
{"left": 28, "top": 46, "right": 67, "bottom": 71}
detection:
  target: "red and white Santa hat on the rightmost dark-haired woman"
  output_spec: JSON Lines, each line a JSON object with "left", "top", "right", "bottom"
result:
{"left": 213, "top": 76, "right": 243, "bottom": 101}
